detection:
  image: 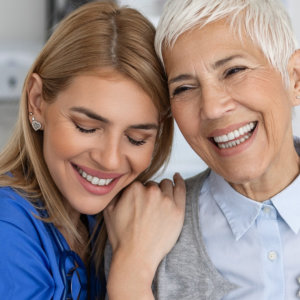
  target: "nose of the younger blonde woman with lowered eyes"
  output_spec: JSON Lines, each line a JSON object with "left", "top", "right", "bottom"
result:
{"left": 91, "top": 134, "right": 122, "bottom": 171}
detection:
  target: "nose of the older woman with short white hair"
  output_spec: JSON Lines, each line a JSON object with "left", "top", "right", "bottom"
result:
{"left": 201, "top": 85, "right": 236, "bottom": 120}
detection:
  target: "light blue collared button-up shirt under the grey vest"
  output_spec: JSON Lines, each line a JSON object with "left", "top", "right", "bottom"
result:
{"left": 199, "top": 171, "right": 300, "bottom": 300}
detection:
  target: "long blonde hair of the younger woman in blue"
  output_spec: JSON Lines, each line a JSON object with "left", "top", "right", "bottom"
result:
{"left": 0, "top": 2, "right": 173, "bottom": 282}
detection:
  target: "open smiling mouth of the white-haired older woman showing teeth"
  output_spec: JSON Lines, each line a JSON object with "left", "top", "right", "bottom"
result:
{"left": 210, "top": 121, "right": 258, "bottom": 149}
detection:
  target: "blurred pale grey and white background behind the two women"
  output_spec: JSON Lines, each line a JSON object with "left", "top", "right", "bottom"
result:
{"left": 0, "top": 0, "right": 300, "bottom": 178}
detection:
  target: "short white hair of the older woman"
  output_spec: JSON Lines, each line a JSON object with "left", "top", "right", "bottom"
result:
{"left": 155, "top": 0, "right": 297, "bottom": 85}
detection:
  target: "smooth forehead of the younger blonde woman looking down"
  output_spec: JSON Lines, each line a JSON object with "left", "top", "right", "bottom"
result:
{"left": 53, "top": 71, "right": 158, "bottom": 120}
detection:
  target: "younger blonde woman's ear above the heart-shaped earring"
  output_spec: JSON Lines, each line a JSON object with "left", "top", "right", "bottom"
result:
{"left": 26, "top": 73, "right": 45, "bottom": 123}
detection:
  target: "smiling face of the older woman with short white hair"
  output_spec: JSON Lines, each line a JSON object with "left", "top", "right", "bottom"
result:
{"left": 164, "top": 21, "right": 295, "bottom": 183}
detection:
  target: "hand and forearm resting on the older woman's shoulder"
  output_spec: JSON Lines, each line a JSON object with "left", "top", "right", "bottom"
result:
{"left": 104, "top": 174, "right": 185, "bottom": 300}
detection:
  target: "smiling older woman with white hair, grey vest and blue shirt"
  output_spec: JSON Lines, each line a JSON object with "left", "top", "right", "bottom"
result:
{"left": 151, "top": 0, "right": 300, "bottom": 300}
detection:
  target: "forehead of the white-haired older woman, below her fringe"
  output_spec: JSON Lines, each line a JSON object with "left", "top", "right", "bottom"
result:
{"left": 163, "top": 20, "right": 267, "bottom": 74}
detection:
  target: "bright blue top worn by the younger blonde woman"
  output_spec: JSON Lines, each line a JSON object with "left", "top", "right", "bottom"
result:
{"left": 0, "top": 187, "right": 101, "bottom": 300}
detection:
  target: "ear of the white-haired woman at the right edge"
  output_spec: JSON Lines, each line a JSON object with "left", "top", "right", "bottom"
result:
{"left": 288, "top": 49, "right": 300, "bottom": 106}
